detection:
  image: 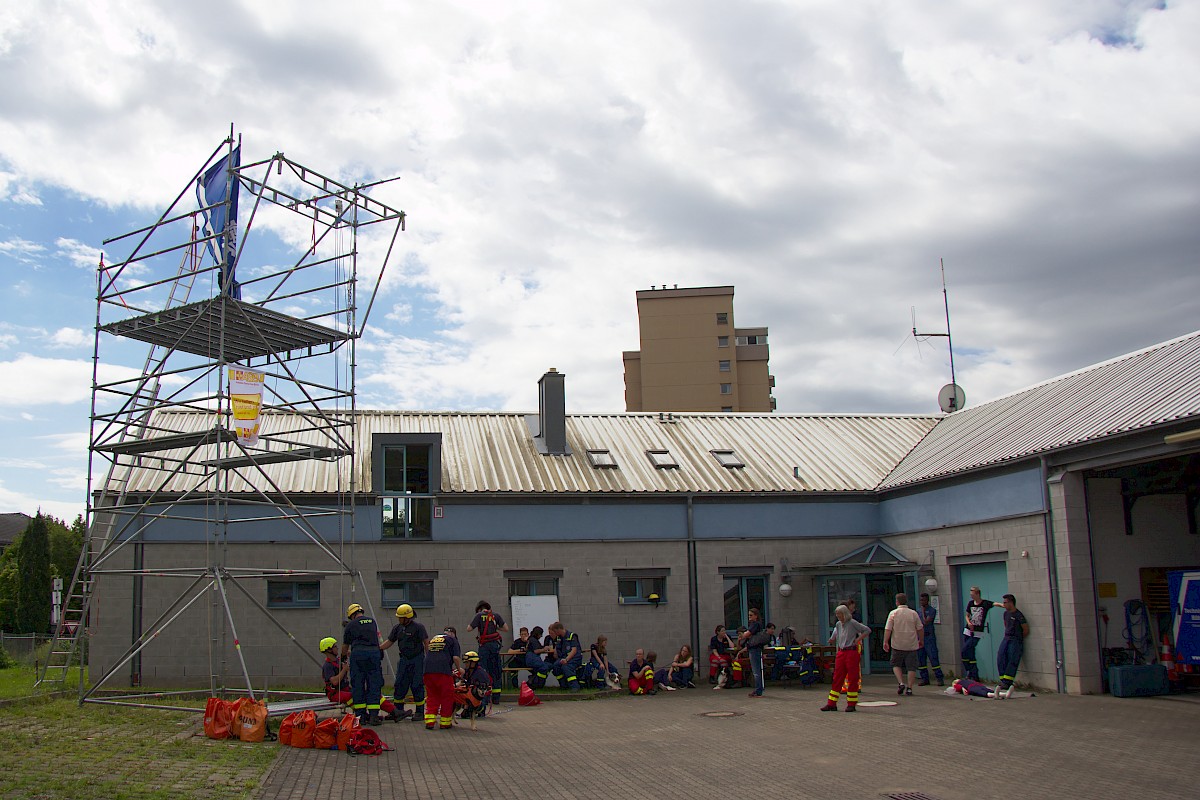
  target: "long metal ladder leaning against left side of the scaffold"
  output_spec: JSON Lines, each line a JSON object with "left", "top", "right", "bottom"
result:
{"left": 34, "top": 222, "right": 200, "bottom": 691}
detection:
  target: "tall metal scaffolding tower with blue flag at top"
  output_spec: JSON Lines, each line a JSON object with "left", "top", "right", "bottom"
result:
{"left": 38, "top": 130, "right": 406, "bottom": 704}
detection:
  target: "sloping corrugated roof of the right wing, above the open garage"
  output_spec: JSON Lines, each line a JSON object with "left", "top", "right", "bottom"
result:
{"left": 880, "top": 331, "right": 1200, "bottom": 489}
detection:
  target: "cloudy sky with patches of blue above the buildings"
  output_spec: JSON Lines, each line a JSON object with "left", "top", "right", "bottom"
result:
{"left": 0, "top": 0, "right": 1200, "bottom": 519}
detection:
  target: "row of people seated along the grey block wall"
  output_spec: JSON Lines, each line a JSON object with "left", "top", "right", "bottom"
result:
{"left": 502, "top": 622, "right": 818, "bottom": 694}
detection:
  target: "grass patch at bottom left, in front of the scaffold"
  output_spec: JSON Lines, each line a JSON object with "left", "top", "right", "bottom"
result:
{"left": 0, "top": 695, "right": 278, "bottom": 800}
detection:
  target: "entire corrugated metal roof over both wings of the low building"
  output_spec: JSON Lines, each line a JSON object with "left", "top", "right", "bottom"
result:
{"left": 105, "top": 331, "right": 1200, "bottom": 494}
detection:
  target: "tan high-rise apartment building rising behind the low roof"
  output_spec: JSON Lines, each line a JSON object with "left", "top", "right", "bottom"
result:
{"left": 622, "top": 287, "right": 775, "bottom": 411}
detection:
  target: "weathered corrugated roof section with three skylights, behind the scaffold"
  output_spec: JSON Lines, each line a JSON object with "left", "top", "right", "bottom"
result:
{"left": 112, "top": 411, "right": 936, "bottom": 494}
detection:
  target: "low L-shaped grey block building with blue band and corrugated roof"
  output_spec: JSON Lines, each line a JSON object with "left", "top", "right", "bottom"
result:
{"left": 90, "top": 332, "right": 1200, "bottom": 693}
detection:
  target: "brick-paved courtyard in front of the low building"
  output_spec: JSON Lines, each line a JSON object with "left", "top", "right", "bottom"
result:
{"left": 258, "top": 678, "right": 1200, "bottom": 800}
